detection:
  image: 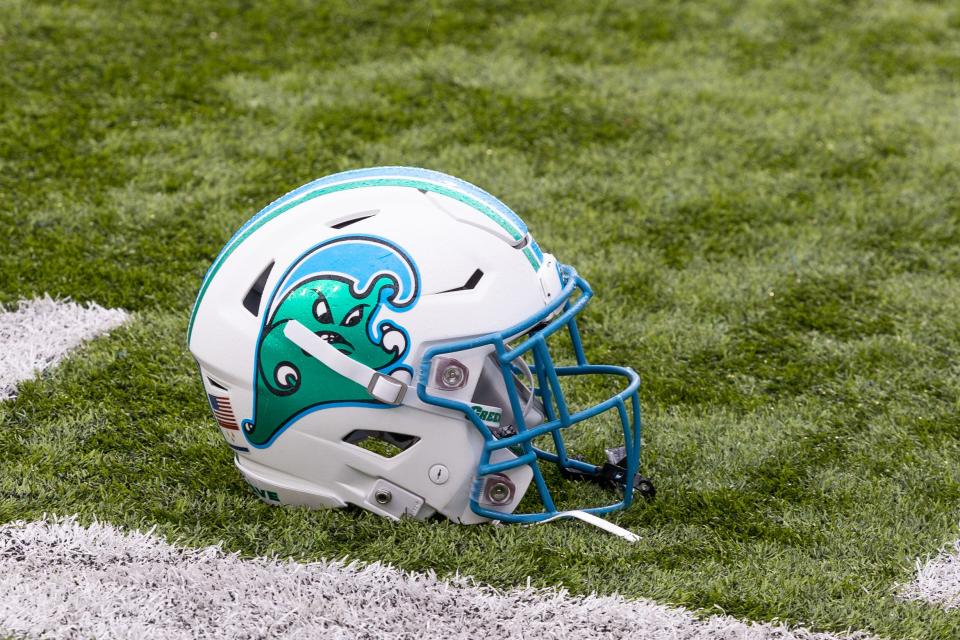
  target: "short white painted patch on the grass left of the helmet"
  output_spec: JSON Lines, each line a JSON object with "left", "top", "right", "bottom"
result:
{"left": 0, "top": 296, "right": 129, "bottom": 401}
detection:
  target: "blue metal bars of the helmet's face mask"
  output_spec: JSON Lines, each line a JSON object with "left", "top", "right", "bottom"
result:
{"left": 417, "top": 266, "right": 646, "bottom": 523}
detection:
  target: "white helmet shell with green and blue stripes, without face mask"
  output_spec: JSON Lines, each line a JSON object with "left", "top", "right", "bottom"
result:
{"left": 189, "top": 167, "right": 560, "bottom": 522}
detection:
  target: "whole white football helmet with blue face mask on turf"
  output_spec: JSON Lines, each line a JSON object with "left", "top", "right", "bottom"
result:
{"left": 188, "top": 167, "right": 653, "bottom": 523}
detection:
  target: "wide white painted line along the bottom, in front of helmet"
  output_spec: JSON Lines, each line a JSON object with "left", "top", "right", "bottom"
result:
{"left": 0, "top": 518, "right": 870, "bottom": 640}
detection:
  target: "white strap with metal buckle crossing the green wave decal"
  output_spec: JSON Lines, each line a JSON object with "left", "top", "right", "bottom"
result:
{"left": 283, "top": 320, "right": 422, "bottom": 407}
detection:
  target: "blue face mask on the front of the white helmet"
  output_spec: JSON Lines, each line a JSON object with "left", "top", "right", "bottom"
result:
{"left": 417, "top": 266, "right": 653, "bottom": 523}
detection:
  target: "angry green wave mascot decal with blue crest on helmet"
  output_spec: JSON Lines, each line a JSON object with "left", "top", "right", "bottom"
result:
{"left": 243, "top": 235, "right": 420, "bottom": 447}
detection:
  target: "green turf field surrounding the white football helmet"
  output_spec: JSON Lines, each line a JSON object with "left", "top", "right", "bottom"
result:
{"left": 0, "top": 0, "right": 960, "bottom": 638}
